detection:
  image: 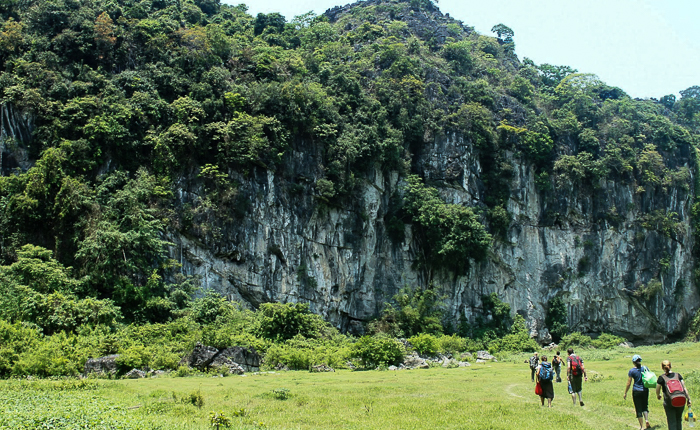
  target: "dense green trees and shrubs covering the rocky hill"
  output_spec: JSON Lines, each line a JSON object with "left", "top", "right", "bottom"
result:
{"left": 0, "top": 0, "right": 700, "bottom": 374}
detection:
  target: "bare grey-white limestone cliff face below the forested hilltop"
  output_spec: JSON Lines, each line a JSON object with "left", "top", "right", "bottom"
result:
{"left": 170, "top": 131, "right": 700, "bottom": 343}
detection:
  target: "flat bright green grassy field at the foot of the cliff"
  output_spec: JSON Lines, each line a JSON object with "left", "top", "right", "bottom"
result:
{"left": 0, "top": 343, "right": 700, "bottom": 430}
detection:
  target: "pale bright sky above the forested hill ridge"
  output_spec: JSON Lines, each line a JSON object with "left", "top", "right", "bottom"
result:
{"left": 231, "top": 0, "right": 700, "bottom": 98}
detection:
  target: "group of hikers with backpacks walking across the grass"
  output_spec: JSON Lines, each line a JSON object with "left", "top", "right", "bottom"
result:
{"left": 529, "top": 348, "right": 695, "bottom": 430}
